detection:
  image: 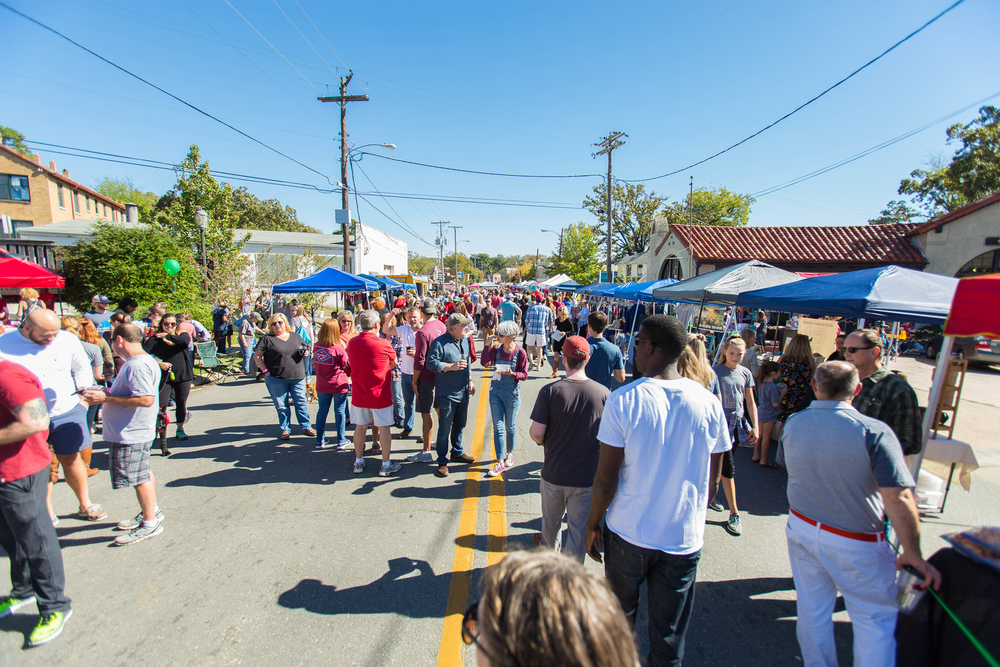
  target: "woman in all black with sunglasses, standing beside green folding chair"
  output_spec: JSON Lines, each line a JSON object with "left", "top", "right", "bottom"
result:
{"left": 142, "top": 313, "right": 194, "bottom": 456}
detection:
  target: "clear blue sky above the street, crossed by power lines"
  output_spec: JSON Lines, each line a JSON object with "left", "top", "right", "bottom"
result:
{"left": 0, "top": 0, "right": 1000, "bottom": 255}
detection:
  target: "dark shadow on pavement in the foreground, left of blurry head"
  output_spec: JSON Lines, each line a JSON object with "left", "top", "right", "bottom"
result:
{"left": 278, "top": 558, "right": 479, "bottom": 618}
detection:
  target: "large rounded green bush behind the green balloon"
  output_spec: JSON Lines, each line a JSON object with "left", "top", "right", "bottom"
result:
{"left": 59, "top": 222, "right": 209, "bottom": 321}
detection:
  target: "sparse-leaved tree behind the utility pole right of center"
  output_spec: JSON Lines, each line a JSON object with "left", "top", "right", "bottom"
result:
{"left": 583, "top": 182, "right": 667, "bottom": 261}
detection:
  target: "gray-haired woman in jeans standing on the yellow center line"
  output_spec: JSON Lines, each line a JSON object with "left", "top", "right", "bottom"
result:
{"left": 480, "top": 320, "right": 528, "bottom": 477}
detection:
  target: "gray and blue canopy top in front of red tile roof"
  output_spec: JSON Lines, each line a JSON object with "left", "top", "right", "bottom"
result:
{"left": 653, "top": 259, "right": 802, "bottom": 304}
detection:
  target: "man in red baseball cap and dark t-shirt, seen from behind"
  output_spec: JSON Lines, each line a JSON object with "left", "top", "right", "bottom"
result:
{"left": 528, "top": 336, "right": 611, "bottom": 563}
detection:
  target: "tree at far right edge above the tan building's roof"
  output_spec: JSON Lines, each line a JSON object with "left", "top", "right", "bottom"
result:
{"left": 899, "top": 106, "right": 1000, "bottom": 217}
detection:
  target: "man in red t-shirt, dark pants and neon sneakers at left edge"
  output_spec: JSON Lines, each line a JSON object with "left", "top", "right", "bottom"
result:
{"left": 0, "top": 361, "right": 73, "bottom": 646}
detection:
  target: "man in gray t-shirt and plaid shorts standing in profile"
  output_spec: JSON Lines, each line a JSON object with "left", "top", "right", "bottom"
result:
{"left": 84, "top": 324, "right": 163, "bottom": 545}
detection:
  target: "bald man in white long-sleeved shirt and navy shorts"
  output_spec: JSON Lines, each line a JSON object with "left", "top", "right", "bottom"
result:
{"left": 0, "top": 309, "right": 108, "bottom": 523}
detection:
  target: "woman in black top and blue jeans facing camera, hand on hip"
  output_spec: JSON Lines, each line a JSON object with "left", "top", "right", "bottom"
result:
{"left": 253, "top": 313, "right": 316, "bottom": 440}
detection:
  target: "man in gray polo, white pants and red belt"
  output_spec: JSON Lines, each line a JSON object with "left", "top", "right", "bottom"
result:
{"left": 781, "top": 361, "right": 941, "bottom": 665}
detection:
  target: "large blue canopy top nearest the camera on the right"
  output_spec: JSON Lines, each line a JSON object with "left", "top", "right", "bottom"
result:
{"left": 736, "top": 266, "right": 958, "bottom": 324}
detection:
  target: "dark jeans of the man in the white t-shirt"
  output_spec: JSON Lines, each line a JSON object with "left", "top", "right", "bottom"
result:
{"left": 604, "top": 525, "right": 701, "bottom": 667}
